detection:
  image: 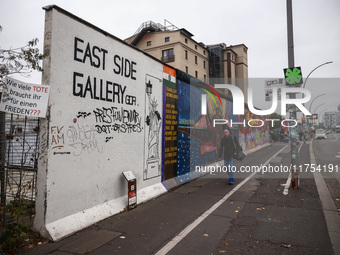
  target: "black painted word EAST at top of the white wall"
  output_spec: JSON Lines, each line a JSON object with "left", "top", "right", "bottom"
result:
{"left": 74, "top": 37, "right": 108, "bottom": 70}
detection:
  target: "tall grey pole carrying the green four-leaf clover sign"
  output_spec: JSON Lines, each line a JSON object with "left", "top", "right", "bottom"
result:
{"left": 287, "top": 0, "right": 300, "bottom": 188}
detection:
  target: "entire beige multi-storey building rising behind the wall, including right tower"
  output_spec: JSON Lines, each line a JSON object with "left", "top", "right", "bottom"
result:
{"left": 125, "top": 21, "right": 248, "bottom": 98}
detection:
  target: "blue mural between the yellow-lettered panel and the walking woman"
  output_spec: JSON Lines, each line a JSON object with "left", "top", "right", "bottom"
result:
{"left": 177, "top": 80, "right": 237, "bottom": 176}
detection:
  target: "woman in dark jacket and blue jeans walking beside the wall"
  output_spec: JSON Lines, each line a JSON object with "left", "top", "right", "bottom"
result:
{"left": 218, "top": 129, "right": 240, "bottom": 185}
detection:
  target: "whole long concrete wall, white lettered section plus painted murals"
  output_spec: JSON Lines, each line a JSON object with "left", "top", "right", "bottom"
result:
{"left": 34, "top": 6, "right": 268, "bottom": 240}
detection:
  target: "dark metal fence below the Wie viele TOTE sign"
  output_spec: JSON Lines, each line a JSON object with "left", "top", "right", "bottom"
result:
{"left": 0, "top": 112, "right": 39, "bottom": 224}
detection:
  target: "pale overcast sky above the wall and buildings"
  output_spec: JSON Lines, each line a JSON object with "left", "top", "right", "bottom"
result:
{"left": 0, "top": 0, "right": 340, "bottom": 119}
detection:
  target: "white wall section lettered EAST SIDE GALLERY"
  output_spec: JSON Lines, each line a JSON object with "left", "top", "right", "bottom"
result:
{"left": 34, "top": 7, "right": 166, "bottom": 240}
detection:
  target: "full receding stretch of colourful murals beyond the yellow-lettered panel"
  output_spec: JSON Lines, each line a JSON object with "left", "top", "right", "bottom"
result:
{"left": 176, "top": 80, "right": 269, "bottom": 176}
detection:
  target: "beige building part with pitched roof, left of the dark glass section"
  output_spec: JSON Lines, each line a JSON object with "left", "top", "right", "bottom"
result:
{"left": 125, "top": 21, "right": 209, "bottom": 82}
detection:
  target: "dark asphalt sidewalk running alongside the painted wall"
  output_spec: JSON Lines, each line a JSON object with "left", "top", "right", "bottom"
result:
{"left": 23, "top": 142, "right": 334, "bottom": 255}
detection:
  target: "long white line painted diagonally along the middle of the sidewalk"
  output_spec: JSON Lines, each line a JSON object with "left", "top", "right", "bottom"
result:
{"left": 155, "top": 145, "right": 288, "bottom": 255}
